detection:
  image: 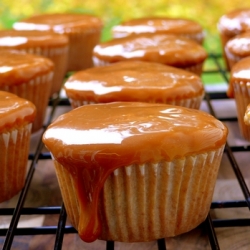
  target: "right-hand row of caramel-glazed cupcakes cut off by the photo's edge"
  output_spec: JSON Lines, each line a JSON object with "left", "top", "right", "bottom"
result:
{"left": 218, "top": 8, "right": 250, "bottom": 141}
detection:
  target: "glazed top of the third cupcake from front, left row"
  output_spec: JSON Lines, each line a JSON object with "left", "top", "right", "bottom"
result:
{"left": 0, "top": 30, "right": 69, "bottom": 50}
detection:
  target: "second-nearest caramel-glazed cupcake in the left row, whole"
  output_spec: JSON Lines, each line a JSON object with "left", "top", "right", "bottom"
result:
{"left": 0, "top": 50, "right": 54, "bottom": 132}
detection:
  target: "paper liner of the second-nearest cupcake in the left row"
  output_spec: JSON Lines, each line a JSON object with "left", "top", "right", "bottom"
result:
{"left": 1, "top": 72, "right": 53, "bottom": 132}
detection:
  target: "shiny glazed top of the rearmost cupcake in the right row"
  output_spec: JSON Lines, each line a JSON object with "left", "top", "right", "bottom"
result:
{"left": 218, "top": 8, "right": 250, "bottom": 36}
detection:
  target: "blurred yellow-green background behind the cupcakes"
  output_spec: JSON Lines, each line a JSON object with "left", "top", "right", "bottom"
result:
{"left": 0, "top": 0, "right": 250, "bottom": 52}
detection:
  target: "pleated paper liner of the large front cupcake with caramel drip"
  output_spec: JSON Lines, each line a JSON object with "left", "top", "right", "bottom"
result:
{"left": 54, "top": 146, "right": 224, "bottom": 242}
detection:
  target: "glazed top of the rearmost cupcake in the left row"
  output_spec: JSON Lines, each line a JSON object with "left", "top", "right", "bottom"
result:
{"left": 13, "top": 13, "right": 103, "bottom": 33}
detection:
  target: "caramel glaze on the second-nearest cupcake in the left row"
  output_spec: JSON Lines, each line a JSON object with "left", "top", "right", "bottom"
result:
{"left": 0, "top": 50, "right": 54, "bottom": 88}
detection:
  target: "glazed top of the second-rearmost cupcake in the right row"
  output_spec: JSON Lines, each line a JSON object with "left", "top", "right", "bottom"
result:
{"left": 225, "top": 30, "right": 250, "bottom": 57}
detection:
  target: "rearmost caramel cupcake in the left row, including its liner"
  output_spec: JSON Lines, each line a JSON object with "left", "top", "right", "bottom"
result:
{"left": 13, "top": 13, "right": 103, "bottom": 71}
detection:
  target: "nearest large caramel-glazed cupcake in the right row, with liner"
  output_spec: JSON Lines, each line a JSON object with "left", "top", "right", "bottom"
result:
{"left": 227, "top": 57, "right": 250, "bottom": 141}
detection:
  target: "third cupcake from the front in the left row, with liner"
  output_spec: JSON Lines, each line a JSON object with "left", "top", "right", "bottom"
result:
{"left": 0, "top": 30, "right": 69, "bottom": 96}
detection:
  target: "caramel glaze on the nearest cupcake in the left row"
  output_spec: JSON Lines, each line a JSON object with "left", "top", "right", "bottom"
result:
{"left": 0, "top": 91, "right": 36, "bottom": 133}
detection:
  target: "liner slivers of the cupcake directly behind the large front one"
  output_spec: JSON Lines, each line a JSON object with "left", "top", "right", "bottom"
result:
{"left": 69, "top": 94, "right": 204, "bottom": 109}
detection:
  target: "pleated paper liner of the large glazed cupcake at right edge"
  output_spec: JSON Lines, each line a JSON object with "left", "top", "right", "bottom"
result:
{"left": 233, "top": 80, "right": 250, "bottom": 141}
